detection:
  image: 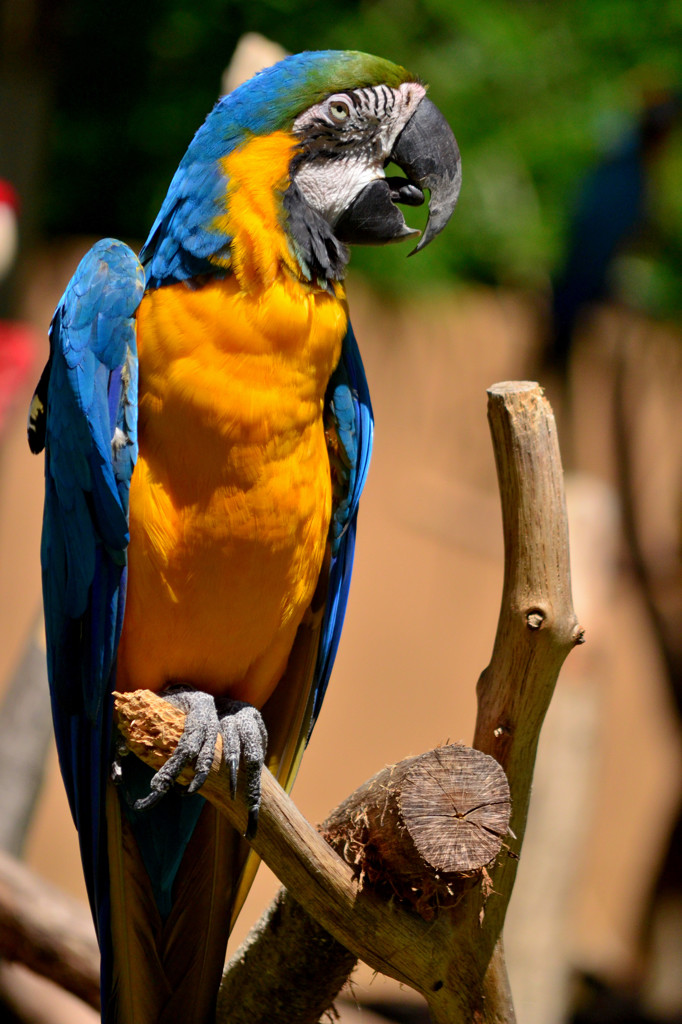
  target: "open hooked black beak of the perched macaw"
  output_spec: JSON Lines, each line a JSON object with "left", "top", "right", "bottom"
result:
{"left": 334, "top": 97, "right": 462, "bottom": 256}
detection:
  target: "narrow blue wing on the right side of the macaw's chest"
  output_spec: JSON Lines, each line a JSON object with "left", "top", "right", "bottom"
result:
{"left": 307, "top": 323, "right": 374, "bottom": 739}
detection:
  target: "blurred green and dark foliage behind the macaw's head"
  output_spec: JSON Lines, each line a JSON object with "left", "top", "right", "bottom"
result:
{"left": 45, "top": 0, "right": 682, "bottom": 306}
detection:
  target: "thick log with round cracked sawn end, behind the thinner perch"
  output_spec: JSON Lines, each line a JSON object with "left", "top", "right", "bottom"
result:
{"left": 216, "top": 744, "right": 510, "bottom": 1024}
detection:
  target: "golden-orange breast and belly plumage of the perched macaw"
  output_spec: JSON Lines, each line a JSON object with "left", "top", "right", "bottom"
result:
{"left": 117, "top": 136, "right": 347, "bottom": 707}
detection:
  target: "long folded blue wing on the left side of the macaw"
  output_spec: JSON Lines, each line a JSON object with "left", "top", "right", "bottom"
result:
{"left": 36, "top": 239, "right": 144, "bottom": 939}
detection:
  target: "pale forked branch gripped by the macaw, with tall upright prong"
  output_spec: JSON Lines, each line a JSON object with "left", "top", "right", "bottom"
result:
{"left": 111, "top": 382, "right": 583, "bottom": 1024}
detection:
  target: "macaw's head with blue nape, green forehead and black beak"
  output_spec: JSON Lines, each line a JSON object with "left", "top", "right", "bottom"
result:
{"left": 140, "top": 50, "right": 462, "bottom": 285}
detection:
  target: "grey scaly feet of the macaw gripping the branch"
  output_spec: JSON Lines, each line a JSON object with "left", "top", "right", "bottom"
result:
{"left": 134, "top": 686, "right": 267, "bottom": 839}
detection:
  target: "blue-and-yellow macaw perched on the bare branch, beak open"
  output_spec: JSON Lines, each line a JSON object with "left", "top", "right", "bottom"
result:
{"left": 29, "top": 51, "right": 460, "bottom": 1024}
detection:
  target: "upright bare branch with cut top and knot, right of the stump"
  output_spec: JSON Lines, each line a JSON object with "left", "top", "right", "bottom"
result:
{"left": 474, "top": 381, "right": 585, "bottom": 1021}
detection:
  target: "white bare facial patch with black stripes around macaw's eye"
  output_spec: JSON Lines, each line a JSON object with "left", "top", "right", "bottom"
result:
{"left": 293, "top": 82, "right": 426, "bottom": 227}
